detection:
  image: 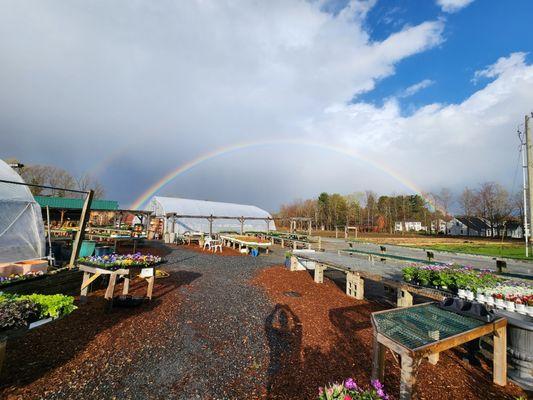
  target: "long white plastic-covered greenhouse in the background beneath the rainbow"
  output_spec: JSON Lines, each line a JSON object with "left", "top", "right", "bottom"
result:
{"left": 146, "top": 196, "right": 276, "bottom": 233}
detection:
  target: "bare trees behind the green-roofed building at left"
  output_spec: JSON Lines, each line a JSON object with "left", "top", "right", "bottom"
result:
{"left": 5, "top": 159, "right": 105, "bottom": 199}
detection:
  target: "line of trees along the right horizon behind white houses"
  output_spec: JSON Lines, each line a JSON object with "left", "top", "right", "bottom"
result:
{"left": 276, "top": 182, "right": 523, "bottom": 233}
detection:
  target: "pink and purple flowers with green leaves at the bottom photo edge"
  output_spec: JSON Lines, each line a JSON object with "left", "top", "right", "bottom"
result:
{"left": 318, "top": 378, "right": 389, "bottom": 400}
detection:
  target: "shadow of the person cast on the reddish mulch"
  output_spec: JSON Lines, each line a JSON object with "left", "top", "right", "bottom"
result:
{"left": 265, "top": 304, "right": 302, "bottom": 399}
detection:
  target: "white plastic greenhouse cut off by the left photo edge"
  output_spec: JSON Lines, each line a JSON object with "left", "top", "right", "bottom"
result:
{"left": 0, "top": 160, "right": 45, "bottom": 263}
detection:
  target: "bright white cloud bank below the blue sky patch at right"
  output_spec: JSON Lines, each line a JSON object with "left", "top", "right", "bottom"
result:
{"left": 313, "top": 54, "right": 533, "bottom": 190}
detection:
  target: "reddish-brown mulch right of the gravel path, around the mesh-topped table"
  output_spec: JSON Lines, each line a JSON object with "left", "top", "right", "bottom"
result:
{"left": 253, "top": 267, "right": 525, "bottom": 400}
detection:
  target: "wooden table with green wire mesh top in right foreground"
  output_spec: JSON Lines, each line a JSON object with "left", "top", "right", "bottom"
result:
{"left": 372, "top": 303, "right": 507, "bottom": 400}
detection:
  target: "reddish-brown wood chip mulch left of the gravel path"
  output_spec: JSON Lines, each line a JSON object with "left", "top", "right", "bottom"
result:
{"left": 0, "top": 271, "right": 198, "bottom": 400}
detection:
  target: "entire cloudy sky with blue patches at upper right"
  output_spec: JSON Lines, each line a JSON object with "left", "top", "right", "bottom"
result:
{"left": 0, "top": 0, "right": 533, "bottom": 210}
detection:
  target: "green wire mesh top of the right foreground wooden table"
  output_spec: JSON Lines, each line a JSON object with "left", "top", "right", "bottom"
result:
{"left": 372, "top": 304, "right": 486, "bottom": 350}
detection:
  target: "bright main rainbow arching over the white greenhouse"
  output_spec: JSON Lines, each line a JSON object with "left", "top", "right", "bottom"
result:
{"left": 130, "top": 139, "right": 433, "bottom": 210}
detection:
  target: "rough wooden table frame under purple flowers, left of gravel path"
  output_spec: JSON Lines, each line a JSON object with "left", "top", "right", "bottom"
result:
{"left": 79, "top": 265, "right": 155, "bottom": 303}
